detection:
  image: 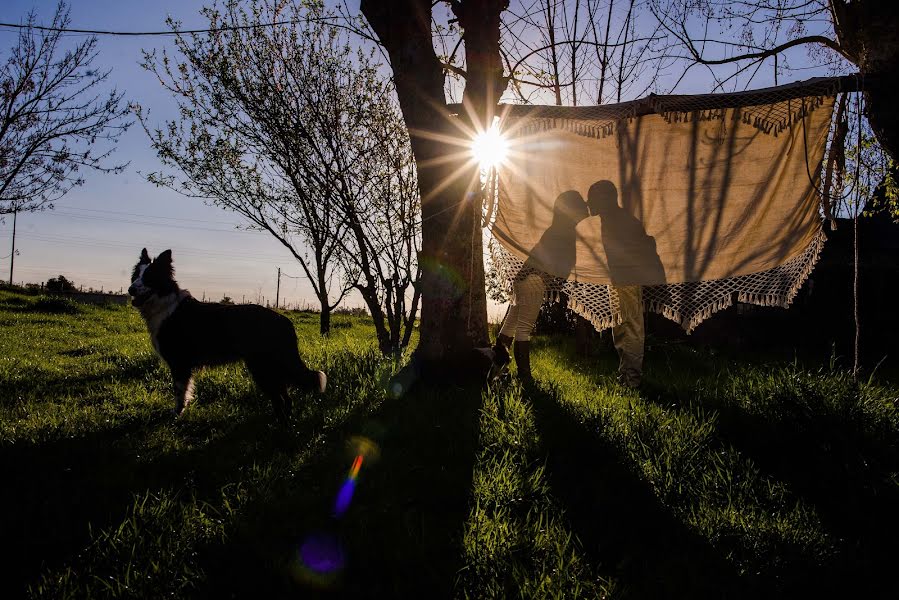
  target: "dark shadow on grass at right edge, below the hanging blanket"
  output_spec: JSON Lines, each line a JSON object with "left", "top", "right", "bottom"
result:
{"left": 647, "top": 378, "right": 899, "bottom": 598}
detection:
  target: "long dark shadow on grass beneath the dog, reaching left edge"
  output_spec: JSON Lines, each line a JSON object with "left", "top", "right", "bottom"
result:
{"left": 0, "top": 384, "right": 370, "bottom": 597}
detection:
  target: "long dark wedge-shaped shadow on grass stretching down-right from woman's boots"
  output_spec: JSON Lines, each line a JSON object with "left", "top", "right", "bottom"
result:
{"left": 526, "top": 387, "right": 753, "bottom": 598}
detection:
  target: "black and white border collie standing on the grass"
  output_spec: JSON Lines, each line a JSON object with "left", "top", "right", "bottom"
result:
{"left": 128, "top": 248, "right": 327, "bottom": 423}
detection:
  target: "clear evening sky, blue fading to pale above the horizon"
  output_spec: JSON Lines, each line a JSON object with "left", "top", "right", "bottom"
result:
{"left": 0, "top": 0, "right": 836, "bottom": 320}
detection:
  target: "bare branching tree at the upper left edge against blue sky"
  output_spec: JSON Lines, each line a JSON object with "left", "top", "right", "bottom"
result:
{"left": 0, "top": 2, "right": 130, "bottom": 215}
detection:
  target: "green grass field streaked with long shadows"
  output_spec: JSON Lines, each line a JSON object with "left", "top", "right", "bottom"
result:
{"left": 0, "top": 291, "right": 899, "bottom": 599}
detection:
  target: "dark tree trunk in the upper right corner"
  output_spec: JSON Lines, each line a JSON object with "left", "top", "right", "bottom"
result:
{"left": 831, "top": 0, "right": 899, "bottom": 161}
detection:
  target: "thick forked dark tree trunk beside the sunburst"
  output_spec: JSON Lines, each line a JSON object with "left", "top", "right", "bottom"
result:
{"left": 360, "top": 0, "right": 506, "bottom": 366}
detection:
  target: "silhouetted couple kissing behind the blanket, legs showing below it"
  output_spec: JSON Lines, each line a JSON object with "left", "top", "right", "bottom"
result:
{"left": 494, "top": 180, "right": 664, "bottom": 387}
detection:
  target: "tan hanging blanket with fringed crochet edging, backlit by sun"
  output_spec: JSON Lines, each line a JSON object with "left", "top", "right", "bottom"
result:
{"left": 492, "top": 79, "right": 837, "bottom": 332}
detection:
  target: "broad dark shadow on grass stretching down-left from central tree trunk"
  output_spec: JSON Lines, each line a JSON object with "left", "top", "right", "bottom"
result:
{"left": 203, "top": 386, "right": 481, "bottom": 598}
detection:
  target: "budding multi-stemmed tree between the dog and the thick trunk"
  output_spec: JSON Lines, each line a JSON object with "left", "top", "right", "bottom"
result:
{"left": 138, "top": 0, "right": 418, "bottom": 342}
